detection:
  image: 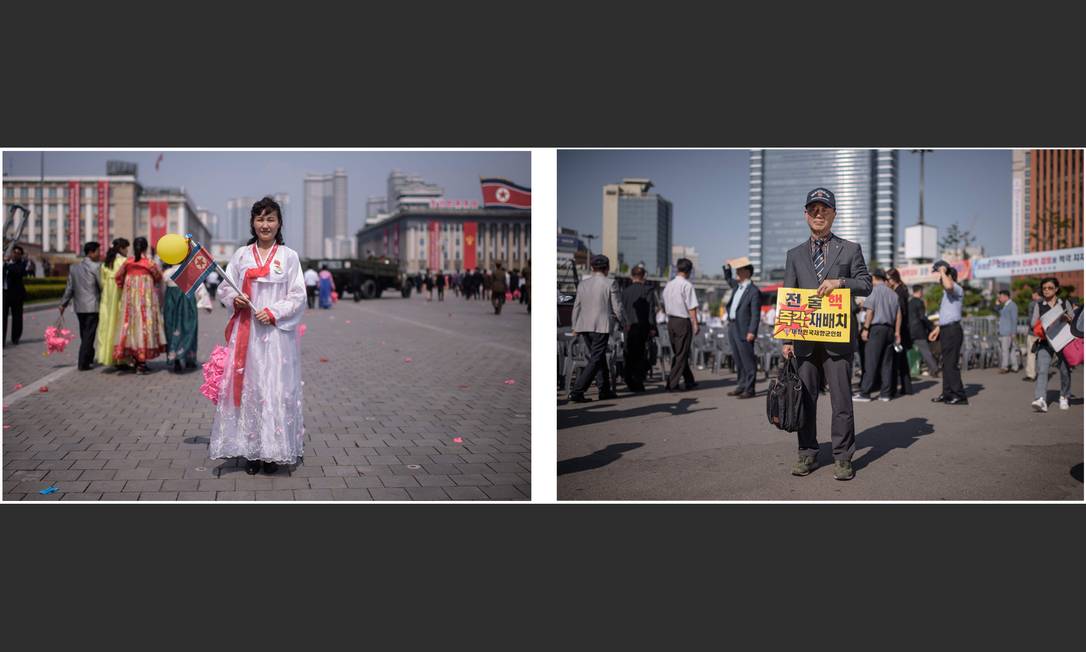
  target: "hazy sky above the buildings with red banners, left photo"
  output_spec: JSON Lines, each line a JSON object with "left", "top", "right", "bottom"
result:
{"left": 3, "top": 151, "right": 532, "bottom": 248}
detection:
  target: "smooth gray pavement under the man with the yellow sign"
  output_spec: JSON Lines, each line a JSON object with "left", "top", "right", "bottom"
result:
{"left": 558, "top": 360, "right": 1083, "bottom": 500}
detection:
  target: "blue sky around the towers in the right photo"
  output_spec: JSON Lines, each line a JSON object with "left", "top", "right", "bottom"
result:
{"left": 558, "top": 150, "right": 1011, "bottom": 274}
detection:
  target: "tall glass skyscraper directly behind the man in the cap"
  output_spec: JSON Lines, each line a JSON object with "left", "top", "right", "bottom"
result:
{"left": 749, "top": 150, "right": 898, "bottom": 280}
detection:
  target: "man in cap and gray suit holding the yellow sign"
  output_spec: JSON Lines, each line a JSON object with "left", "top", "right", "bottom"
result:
{"left": 782, "top": 188, "right": 871, "bottom": 480}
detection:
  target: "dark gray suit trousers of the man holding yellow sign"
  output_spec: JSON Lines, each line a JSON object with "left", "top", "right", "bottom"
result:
{"left": 796, "top": 344, "right": 856, "bottom": 460}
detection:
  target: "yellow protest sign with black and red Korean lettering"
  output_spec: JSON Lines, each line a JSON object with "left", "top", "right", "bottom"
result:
{"left": 773, "top": 288, "right": 853, "bottom": 342}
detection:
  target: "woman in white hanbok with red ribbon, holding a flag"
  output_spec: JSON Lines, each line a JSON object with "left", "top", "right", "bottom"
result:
{"left": 209, "top": 197, "right": 305, "bottom": 475}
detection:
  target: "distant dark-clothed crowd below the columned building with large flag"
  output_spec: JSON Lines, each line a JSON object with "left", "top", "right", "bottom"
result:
{"left": 408, "top": 263, "right": 532, "bottom": 314}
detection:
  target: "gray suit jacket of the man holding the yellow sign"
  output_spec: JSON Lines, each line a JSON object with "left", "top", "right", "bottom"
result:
{"left": 784, "top": 236, "right": 871, "bottom": 358}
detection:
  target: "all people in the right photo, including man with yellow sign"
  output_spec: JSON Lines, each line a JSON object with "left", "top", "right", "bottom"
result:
{"left": 568, "top": 188, "right": 1083, "bottom": 480}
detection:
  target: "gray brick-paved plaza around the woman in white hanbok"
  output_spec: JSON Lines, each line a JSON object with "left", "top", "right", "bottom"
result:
{"left": 3, "top": 292, "right": 531, "bottom": 501}
